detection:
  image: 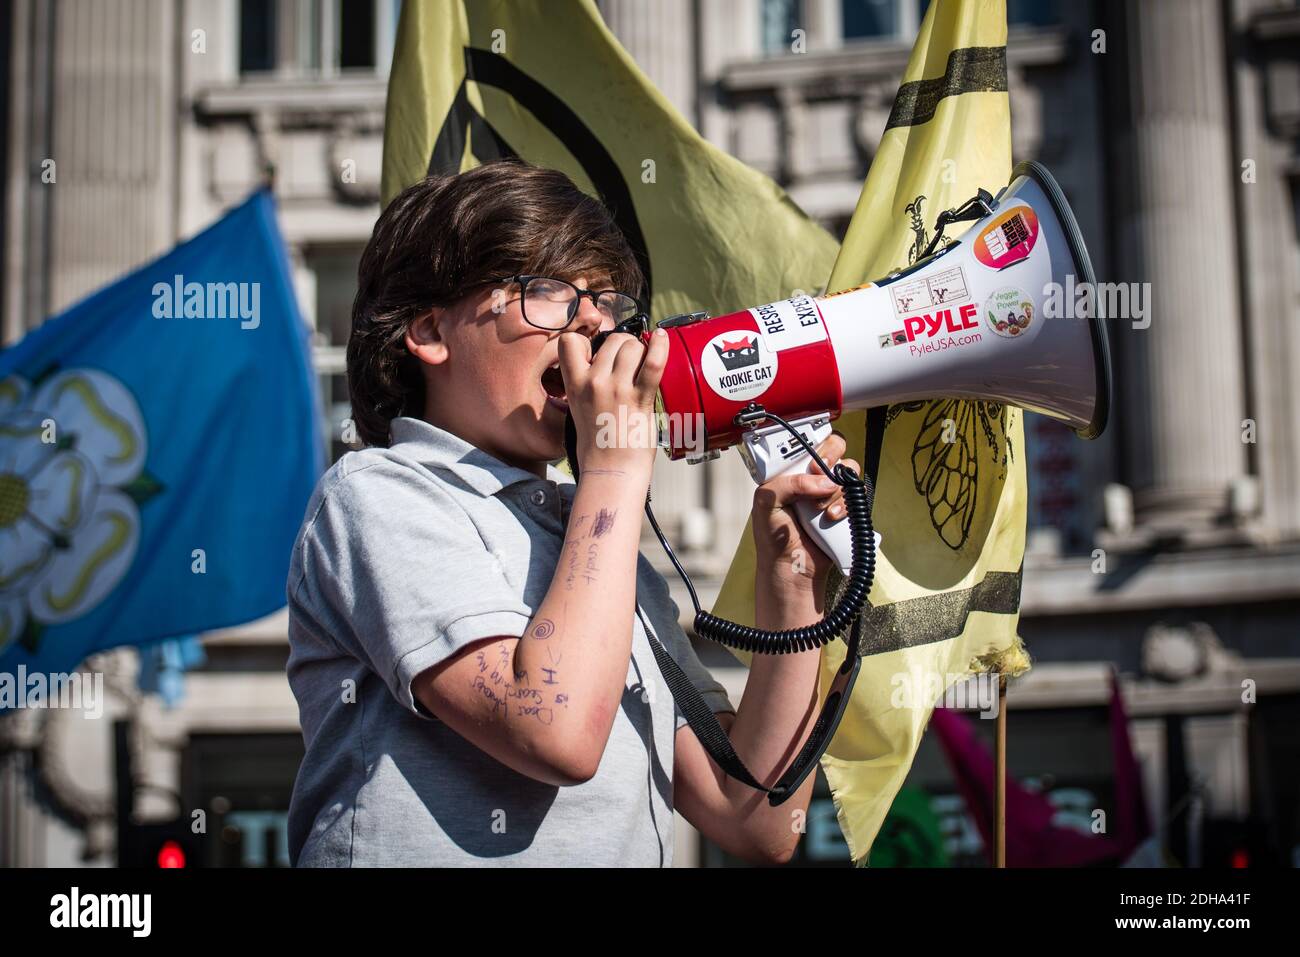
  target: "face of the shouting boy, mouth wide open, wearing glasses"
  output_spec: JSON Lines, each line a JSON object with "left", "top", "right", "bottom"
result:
{"left": 407, "top": 276, "right": 614, "bottom": 476}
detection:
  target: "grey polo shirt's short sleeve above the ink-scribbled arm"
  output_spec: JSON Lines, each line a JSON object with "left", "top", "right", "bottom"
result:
{"left": 299, "top": 460, "right": 530, "bottom": 720}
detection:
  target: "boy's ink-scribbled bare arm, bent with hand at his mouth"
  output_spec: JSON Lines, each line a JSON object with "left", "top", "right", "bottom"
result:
{"left": 411, "top": 330, "right": 668, "bottom": 785}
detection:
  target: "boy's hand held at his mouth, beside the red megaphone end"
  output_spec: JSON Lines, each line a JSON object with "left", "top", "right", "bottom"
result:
{"left": 559, "top": 329, "right": 668, "bottom": 482}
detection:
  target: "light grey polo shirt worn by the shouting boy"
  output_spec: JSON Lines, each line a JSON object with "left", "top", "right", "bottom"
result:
{"left": 287, "top": 417, "right": 735, "bottom": 867}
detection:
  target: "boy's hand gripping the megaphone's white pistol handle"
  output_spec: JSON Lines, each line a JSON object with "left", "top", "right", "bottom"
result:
{"left": 751, "top": 432, "right": 862, "bottom": 593}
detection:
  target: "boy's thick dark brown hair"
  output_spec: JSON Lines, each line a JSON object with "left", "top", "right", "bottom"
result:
{"left": 347, "top": 160, "right": 644, "bottom": 446}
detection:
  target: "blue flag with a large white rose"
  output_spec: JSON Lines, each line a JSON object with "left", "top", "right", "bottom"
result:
{"left": 0, "top": 191, "right": 324, "bottom": 686}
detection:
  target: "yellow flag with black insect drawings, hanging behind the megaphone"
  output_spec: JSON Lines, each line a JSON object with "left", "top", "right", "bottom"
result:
{"left": 714, "top": 0, "right": 1028, "bottom": 863}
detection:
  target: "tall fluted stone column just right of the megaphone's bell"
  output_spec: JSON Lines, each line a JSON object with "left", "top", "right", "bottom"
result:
{"left": 1099, "top": 0, "right": 1247, "bottom": 536}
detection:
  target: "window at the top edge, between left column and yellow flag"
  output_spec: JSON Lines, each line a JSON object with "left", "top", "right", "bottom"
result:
{"left": 239, "top": 0, "right": 402, "bottom": 77}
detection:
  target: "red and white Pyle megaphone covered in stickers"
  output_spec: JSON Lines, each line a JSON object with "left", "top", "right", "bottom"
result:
{"left": 659, "top": 161, "right": 1112, "bottom": 576}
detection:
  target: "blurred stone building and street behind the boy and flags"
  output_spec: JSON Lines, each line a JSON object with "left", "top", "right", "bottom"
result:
{"left": 0, "top": 0, "right": 1300, "bottom": 867}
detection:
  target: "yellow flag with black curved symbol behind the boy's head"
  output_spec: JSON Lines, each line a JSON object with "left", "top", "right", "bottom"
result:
{"left": 382, "top": 0, "right": 839, "bottom": 321}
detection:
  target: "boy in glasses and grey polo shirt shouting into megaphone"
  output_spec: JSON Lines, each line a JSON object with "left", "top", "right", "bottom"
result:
{"left": 287, "top": 161, "right": 844, "bottom": 866}
